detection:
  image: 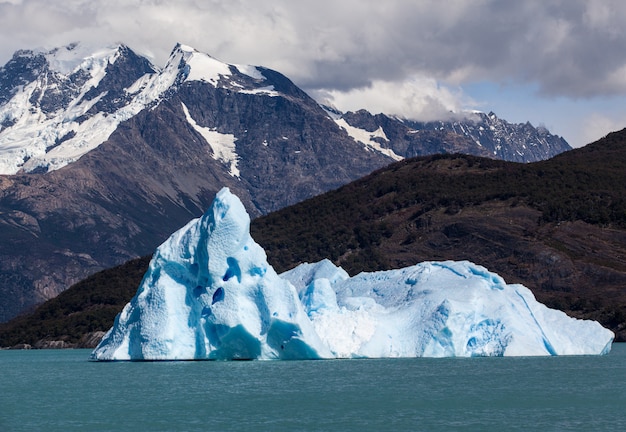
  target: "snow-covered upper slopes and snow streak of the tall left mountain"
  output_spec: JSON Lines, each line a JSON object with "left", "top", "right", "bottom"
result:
{"left": 0, "top": 44, "right": 310, "bottom": 174}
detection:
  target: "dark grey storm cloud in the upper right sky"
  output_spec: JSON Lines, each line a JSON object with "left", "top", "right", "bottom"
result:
{"left": 294, "top": 0, "right": 626, "bottom": 97}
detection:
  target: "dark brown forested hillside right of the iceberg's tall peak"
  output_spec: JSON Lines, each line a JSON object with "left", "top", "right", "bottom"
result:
{"left": 0, "top": 129, "right": 626, "bottom": 346}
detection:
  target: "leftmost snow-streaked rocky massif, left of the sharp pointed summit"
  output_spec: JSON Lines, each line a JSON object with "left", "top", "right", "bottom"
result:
{"left": 0, "top": 44, "right": 158, "bottom": 174}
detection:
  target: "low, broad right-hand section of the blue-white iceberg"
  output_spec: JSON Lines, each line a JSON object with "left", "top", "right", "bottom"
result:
{"left": 282, "top": 261, "right": 614, "bottom": 357}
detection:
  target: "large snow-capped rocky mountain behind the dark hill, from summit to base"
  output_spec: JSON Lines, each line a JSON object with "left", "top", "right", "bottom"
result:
{"left": 0, "top": 44, "right": 568, "bottom": 321}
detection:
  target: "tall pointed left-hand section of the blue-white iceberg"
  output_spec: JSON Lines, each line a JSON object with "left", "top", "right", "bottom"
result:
{"left": 92, "top": 188, "right": 331, "bottom": 360}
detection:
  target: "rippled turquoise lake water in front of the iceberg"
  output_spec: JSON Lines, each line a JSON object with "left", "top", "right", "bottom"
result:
{"left": 0, "top": 344, "right": 626, "bottom": 432}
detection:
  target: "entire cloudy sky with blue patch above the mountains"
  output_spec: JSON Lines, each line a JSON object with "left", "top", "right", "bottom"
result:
{"left": 0, "top": 0, "right": 626, "bottom": 147}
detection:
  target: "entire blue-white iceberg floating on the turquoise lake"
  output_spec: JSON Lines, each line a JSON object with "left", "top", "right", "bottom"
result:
{"left": 90, "top": 188, "right": 614, "bottom": 361}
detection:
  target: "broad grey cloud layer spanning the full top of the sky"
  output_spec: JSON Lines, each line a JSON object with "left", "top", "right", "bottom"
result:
{"left": 0, "top": 0, "right": 626, "bottom": 97}
